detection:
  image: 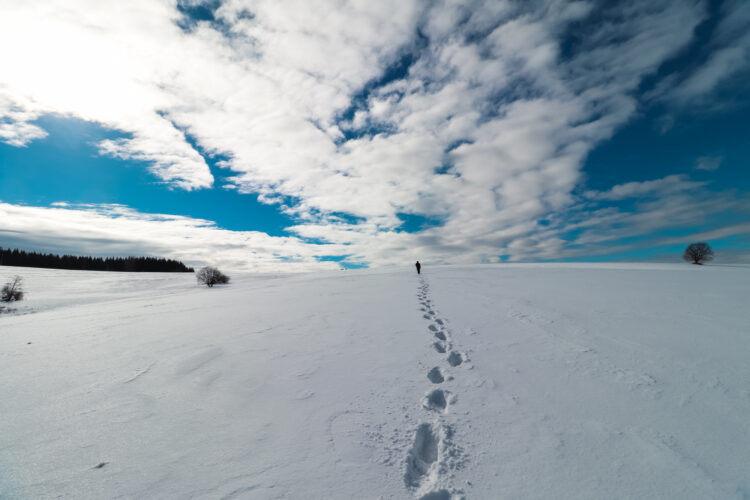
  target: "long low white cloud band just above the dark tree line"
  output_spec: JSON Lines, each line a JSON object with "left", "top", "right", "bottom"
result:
{"left": 0, "top": 202, "right": 347, "bottom": 272}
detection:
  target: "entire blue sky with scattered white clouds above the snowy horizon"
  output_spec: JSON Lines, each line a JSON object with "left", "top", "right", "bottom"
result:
{"left": 0, "top": 0, "right": 750, "bottom": 271}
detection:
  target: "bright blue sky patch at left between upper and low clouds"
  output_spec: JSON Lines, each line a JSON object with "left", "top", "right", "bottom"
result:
{"left": 0, "top": 116, "right": 295, "bottom": 236}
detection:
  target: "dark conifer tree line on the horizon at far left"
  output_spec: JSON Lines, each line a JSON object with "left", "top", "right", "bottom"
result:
{"left": 0, "top": 247, "right": 193, "bottom": 273}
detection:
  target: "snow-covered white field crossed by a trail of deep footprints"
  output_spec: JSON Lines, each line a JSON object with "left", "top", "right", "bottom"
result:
{"left": 0, "top": 265, "right": 750, "bottom": 500}
